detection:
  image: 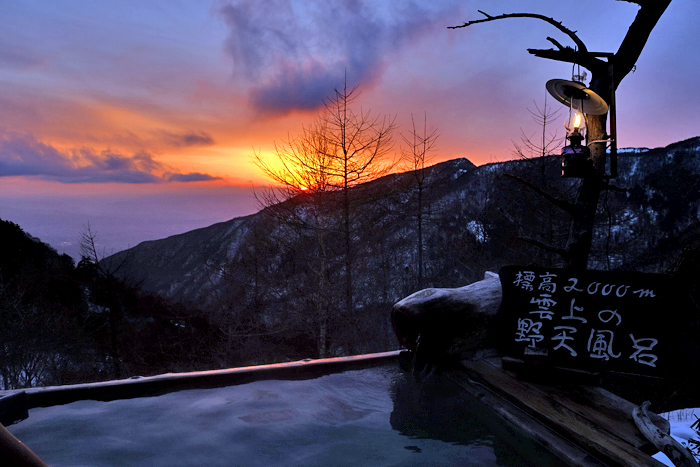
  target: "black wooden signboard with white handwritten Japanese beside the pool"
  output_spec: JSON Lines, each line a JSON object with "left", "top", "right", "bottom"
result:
{"left": 498, "top": 266, "right": 695, "bottom": 376}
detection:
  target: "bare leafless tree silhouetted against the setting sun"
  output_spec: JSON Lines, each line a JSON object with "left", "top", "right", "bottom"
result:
{"left": 253, "top": 77, "right": 396, "bottom": 354}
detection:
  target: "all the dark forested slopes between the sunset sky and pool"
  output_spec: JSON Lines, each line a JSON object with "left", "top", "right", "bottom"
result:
{"left": 5, "top": 138, "right": 700, "bottom": 389}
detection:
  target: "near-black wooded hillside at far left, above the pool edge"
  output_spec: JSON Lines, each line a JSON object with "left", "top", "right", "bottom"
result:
{"left": 0, "top": 220, "right": 217, "bottom": 390}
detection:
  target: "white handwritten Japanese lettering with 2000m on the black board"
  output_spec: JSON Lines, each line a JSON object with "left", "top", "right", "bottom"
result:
{"left": 501, "top": 267, "right": 663, "bottom": 368}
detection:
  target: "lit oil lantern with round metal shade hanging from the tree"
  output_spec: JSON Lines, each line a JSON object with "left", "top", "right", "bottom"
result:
{"left": 547, "top": 79, "right": 608, "bottom": 178}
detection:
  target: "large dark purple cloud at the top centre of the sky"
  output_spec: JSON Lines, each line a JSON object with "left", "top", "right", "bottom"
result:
{"left": 220, "top": 0, "right": 459, "bottom": 114}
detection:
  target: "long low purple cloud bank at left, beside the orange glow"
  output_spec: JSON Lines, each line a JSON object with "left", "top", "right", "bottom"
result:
{"left": 0, "top": 133, "right": 216, "bottom": 183}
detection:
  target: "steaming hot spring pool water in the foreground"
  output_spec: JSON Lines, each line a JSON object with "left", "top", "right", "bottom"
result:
{"left": 9, "top": 364, "right": 563, "bottom": 467}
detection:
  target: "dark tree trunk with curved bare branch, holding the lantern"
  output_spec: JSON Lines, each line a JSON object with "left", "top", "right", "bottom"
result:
{"left": 453, "top": 0, "right": 671, "bottom": 269}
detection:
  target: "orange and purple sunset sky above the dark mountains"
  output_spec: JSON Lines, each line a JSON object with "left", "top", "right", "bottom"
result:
{"left": 0, "top": 0, "right": 700, "bottom": 256}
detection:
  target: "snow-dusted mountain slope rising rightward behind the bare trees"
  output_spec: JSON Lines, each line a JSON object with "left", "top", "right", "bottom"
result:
{"left": 109, "top": 138, "right": 700, "bottom": 360}
